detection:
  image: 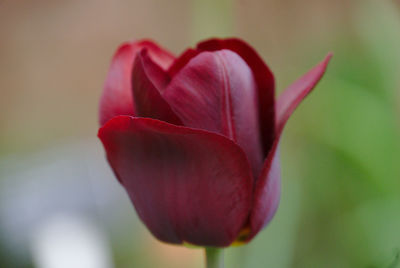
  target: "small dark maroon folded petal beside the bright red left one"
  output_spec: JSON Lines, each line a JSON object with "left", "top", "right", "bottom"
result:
{"left": 132, "top": 49, "right": 181, "bottom": 125}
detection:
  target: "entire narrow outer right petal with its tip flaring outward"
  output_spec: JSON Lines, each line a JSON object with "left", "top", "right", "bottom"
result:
{"left": 246, "top": 54, "right": 332, "bottom": 241}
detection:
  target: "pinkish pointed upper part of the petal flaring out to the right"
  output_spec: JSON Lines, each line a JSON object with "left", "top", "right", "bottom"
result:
{"left": 276, "top": 53, "right": 333, "bottom": 136}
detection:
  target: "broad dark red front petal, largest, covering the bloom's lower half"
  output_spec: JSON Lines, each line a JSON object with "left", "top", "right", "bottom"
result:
{"left": 99, "top": 116, "right": 252, "bottom": 247}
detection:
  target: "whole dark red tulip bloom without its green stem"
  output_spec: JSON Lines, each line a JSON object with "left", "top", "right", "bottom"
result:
{"left": 98, "top": 39, "right": 331, "bottom": 247}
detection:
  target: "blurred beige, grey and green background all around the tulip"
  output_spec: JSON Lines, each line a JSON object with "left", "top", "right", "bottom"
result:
{"left": 0, "top": 0, "right": 400, "bottom": 268}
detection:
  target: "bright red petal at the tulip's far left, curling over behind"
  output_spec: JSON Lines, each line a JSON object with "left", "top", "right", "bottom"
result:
{"left": 99, "top": 40, "right": 174, "bottom": 125}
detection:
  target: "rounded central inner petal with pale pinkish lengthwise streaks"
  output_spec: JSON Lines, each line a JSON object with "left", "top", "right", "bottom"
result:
{"left": 163, "top": 50, "right": 263, "bottom": 177}
